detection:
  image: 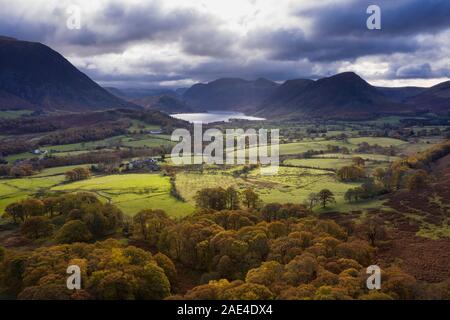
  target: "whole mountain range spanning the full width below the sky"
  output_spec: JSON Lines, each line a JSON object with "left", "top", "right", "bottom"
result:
{"left": 0, "top": 37, "right": 450, "bottom": 119}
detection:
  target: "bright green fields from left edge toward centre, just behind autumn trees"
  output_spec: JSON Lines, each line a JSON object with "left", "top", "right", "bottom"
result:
{"left": 0, "top": 169, "right": 193, "bottom": 217}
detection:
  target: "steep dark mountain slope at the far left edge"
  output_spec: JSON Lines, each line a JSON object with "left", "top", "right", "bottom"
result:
{"left": 0, "top": 37, "right": 137, "bottom": 111}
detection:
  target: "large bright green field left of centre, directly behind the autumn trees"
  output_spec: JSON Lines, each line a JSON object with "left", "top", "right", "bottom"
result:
{"left": 51, "top": 174, "right": 193, "bottom": 217}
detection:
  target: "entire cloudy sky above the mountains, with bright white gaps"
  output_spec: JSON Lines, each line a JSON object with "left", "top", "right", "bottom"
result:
{"left": 0, "top": 0, "right": 450, "bottom": 88}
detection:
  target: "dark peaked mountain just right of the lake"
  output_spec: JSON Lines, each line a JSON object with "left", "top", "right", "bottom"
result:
{"left": 256, "top": 72, "right": 408, "bottom": 118}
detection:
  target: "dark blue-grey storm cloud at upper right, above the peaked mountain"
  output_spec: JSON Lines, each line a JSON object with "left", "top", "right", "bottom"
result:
{"left": 248, "top": 0, "right": 450, "bottom": 65}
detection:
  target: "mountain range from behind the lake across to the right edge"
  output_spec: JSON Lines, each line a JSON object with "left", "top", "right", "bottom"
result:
{"left": 183, "top": 72, "right": 450, "bottom": 119}
